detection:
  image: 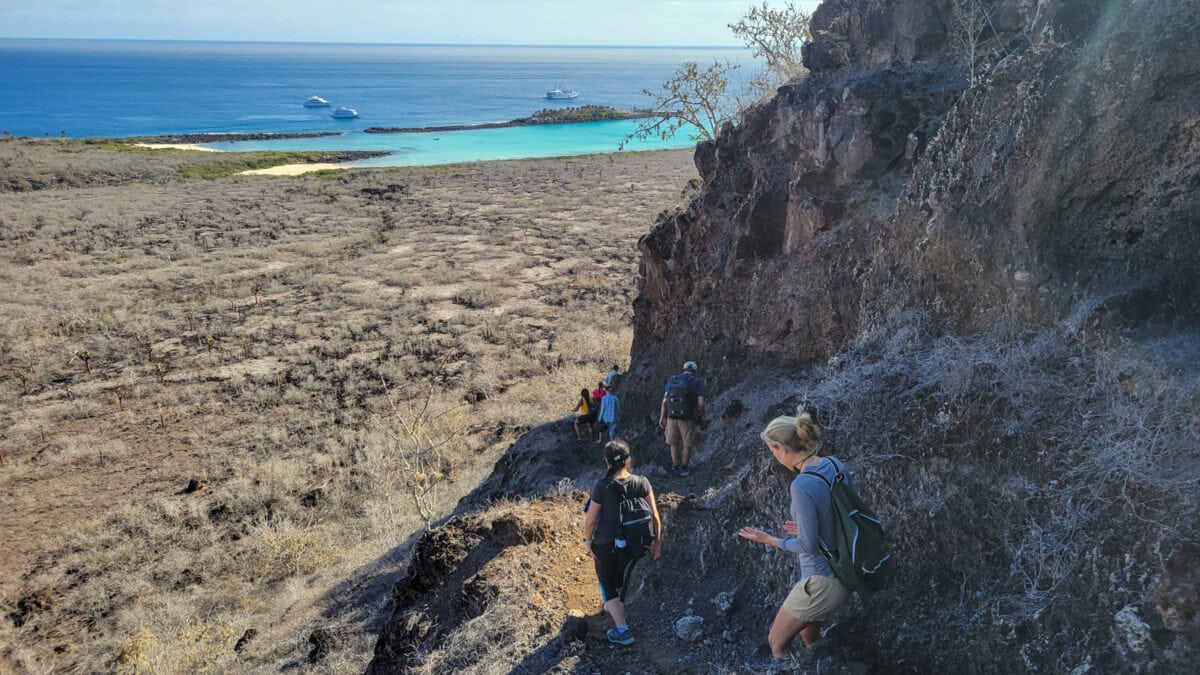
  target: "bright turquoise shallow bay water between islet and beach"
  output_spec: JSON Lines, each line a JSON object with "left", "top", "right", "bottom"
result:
{"left": 204, "top": 120, "right": 695, "bottom": 167}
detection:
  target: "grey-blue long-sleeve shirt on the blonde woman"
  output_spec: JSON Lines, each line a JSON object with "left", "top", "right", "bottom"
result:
{"left": 779, "top": 458, "right": 853, "bottom": 577}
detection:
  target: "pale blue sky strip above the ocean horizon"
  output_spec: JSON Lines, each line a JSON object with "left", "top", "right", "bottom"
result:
{"left": 0, "top": 0, "right": 820, "bottom": 46}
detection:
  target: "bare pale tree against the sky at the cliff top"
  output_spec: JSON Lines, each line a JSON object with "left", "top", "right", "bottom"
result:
{"left": 730, "top": 0, "right": 812, "bottom": 96}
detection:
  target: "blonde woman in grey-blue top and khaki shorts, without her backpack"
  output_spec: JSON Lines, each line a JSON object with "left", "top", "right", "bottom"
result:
{"left": 738, "top": 413, "right": 850, "bottom": 659}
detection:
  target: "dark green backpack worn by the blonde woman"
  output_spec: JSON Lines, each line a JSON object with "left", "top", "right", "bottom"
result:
{"left": 804, "top": 458, "right": 893, "bottom": 597}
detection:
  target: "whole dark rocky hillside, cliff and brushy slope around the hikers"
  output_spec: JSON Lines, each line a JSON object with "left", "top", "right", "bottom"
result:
{"left": 376, "top": 0, "right": 1200, "bottom": 673}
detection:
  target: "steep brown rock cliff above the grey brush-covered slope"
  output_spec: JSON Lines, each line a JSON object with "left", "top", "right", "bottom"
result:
{"left": 631, "top": 0, "right": 1200, "bottom": 396}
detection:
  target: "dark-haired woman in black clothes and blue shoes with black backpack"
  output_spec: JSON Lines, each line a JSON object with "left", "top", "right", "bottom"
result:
{"left": 583, "top": 441, "right": 662, "bottom": 646}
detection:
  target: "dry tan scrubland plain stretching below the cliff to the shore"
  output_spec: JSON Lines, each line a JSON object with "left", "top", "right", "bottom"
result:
{"left": 0, "top": 139, "right": 695, "bottom": 673}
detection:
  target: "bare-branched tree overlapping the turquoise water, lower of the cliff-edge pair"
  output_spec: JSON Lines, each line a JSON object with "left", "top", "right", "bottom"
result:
{"left": 620, "top": 61, "right": 738, "bottom": 149}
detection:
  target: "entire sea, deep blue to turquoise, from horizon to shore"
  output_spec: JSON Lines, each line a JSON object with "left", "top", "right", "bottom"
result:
{"left": 0, "top": 38, "right": 750, "bottom": 163}
